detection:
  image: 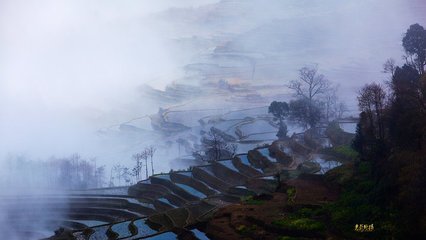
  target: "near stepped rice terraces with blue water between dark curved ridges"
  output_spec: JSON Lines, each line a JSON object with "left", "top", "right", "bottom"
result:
{"left": 0, "top": 129, "right": 346, "bottom": 240}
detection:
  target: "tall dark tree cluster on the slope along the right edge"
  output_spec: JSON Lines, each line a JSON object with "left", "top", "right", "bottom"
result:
{"left": 353, "top": 24, "right": 426, "bottom": 239}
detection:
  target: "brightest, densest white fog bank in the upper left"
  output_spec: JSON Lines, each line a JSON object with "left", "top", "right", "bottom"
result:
{"left": 0, "top": 0, "right": 215, "bottom": 157}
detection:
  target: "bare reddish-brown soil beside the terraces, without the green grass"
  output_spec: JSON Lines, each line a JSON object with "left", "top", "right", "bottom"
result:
{"left": 204, "top": 175, "right": 338, "bottom": 240}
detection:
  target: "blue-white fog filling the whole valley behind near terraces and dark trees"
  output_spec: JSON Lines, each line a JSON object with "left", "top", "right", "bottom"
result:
{"left": 0, "top": 0, "right": 426, "bottom": 239}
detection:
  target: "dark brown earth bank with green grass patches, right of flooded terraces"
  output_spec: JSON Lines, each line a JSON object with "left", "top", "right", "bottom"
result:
{"left": 202, "top": 174, "right": 338, "bottom": 240}
